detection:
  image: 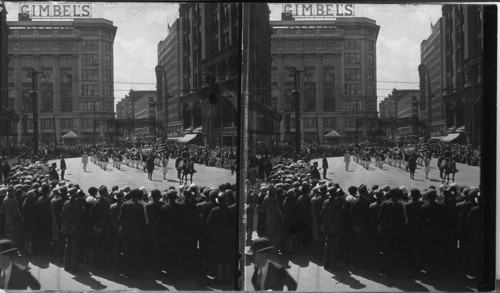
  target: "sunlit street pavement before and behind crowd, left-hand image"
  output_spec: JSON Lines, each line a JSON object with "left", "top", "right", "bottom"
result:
{"left": 19, "top": 158, "right": 236, "bottom": 291}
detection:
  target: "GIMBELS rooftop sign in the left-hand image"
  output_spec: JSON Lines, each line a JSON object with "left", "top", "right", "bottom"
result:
{"left": 19, "top": 2, "right": 92, "bottom": 18}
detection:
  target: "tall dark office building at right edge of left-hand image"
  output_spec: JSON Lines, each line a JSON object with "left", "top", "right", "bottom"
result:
{"left": 178, "top": 2, "right": 240, "bottom": 146}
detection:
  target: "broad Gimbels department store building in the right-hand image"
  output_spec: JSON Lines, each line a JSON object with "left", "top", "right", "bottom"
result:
{"left": 271, "top": 13, "right": 380, "bottom": 144}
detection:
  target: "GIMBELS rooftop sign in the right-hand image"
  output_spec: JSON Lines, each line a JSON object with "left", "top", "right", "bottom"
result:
{"left": 283, "top": 3, "right": 354, "bottom": 18}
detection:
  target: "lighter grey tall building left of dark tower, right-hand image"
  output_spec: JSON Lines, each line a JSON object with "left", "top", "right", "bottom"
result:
{"left": 420, "top": 18, "right": 445, "bottom": 135}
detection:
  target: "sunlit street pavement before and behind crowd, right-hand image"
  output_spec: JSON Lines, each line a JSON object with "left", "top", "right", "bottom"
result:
{"left": 245, "top": 157, "right": 480, "bottom": 292}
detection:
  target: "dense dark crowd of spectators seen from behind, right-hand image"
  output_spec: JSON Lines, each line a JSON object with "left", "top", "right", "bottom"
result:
{"left": 246, "top": 153, "right": 481, "bottom": 277}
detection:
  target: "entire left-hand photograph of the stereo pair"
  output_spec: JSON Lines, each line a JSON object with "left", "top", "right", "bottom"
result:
{"left": 0, "top": 1, "right": 242, "bottom": 291}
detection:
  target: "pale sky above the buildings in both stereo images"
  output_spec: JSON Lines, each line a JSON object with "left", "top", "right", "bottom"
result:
{"left": 6, "top": 2, "right": 441, "bottom": 102}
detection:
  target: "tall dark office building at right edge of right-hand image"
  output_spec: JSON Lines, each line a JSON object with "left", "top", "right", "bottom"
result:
{"left": 441, "top": 4, "right": 484, "bottom": 146}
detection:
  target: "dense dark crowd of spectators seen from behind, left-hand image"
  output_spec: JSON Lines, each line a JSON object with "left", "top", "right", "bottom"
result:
{"left": 0, "top": 156, "right": 237, "bottom": 283}
